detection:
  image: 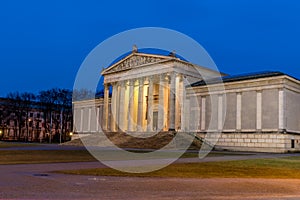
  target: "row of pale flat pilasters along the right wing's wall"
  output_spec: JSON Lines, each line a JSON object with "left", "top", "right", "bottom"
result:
{"left": 182, "top": 89, "right": 286, "bottom": 132}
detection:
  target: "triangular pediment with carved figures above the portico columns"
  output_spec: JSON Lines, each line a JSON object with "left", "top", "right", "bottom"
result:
{"left": 101, "top": 53, "right": 170, "bottom": 75}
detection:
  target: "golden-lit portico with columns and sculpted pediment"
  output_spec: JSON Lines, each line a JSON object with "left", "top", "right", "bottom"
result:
{"left": 102, "top": 49, "right": 197, "bottom": 132}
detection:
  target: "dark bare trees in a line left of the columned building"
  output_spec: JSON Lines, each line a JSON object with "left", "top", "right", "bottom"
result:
{"left": 0, "top": 88, "right": 73, "bottom": 142}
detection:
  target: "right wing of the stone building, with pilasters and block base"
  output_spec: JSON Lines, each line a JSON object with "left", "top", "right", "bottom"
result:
{"left": 187, "top": 74, "right": 300, "bottom": 152}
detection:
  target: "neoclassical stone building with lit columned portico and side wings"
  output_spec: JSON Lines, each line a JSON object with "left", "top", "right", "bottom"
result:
{"left": 73, "top": 48, "right": 300, "bottom": 152}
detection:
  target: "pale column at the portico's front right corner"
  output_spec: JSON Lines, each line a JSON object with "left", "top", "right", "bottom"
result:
{"left": 169, "top": 73, "right": 176, "bottom": 131}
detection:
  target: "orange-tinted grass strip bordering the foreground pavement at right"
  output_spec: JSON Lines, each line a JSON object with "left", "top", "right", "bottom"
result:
{"left": 59, "top": 157, "right": 300, "bottom": 179}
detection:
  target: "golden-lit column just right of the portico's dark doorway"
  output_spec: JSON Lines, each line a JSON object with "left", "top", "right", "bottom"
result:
{"left": 157, "top": 74, "right": 168, "bottom": 131}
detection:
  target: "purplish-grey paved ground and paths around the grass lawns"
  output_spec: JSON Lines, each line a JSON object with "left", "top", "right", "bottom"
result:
{"left": 0, "top": 146, "right": 300, "bottom": 200}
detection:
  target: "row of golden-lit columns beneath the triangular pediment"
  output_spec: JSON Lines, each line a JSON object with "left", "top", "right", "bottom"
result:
{"left": 103, "top": 73, "right": 183, "bottom": 132}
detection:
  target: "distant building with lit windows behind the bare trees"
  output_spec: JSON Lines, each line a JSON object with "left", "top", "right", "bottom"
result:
{"left": 0, "top": 98, "right": 72, "bottom": 142}
